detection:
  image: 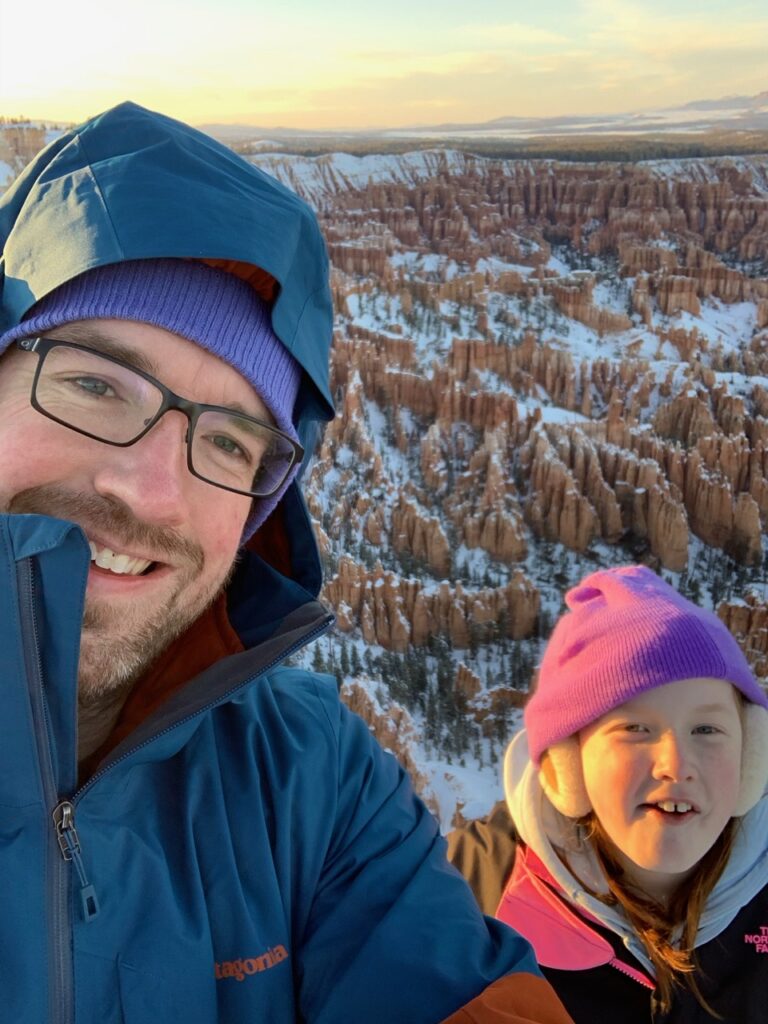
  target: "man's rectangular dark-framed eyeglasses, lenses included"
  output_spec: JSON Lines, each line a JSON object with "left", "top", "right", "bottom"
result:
{"left": 17, "top": 338, "right": 304, "bottom": 498}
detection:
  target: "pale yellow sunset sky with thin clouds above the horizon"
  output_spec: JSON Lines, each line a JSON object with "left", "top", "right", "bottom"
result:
{"left": 0, "top": 0, "right": 768, "bottom": 129}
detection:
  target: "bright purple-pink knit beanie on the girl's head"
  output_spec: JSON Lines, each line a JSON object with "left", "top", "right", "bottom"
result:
{"left": 524, "top": 565, "right": 768, "bottom": 767}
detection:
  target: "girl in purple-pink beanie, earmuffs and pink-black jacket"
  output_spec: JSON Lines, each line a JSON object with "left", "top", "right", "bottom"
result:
{"left": 451, "top": 566, "right": 768, "bottom": 1024}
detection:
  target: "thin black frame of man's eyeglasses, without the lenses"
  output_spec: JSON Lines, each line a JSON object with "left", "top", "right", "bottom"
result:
{"left": 16, "top": 336, "right": 304, "bottom": 498}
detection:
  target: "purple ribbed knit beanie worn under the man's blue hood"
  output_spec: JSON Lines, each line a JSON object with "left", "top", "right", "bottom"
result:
{"left": 0, "top": 259, "right": 301, "bottom": 542}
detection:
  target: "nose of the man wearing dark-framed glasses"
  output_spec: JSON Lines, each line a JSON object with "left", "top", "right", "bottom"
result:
{"left": 93, "top": 411, "right": 195, "bottom": 526}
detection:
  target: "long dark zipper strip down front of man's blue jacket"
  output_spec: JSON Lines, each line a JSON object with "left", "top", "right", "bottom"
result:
{"left": 16, "top": 558, "right": 75, "bottom": 1024}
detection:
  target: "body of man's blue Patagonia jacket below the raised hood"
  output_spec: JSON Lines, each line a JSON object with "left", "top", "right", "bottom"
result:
{"left": 0, "top": 516, "right": 552, "bottom": 1024}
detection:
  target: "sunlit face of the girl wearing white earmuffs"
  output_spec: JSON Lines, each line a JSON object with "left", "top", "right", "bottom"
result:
{"left": 579, "top": 679, "right": 741, "bottom": 900}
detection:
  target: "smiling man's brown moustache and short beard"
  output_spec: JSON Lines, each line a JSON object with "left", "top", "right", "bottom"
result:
{"left": 6, "top": 485, "right": 234, "bottom": 705}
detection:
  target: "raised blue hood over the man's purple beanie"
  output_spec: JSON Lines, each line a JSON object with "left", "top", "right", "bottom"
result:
{"left": 0, "top": 102, "right": 333, "bottom": 595}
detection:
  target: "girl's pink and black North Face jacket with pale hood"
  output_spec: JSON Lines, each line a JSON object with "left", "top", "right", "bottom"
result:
{"left": 449, "top": 731, "right": 768, "bottom": 1024}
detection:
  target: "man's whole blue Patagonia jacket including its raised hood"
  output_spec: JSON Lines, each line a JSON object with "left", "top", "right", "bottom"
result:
{"left": 0, "top": 103, "right": 568, "bottom": 1024}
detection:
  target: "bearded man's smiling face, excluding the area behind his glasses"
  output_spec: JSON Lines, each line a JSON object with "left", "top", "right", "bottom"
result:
{"left": 0, "top": 319, "right": 259, "bottom": 698}
